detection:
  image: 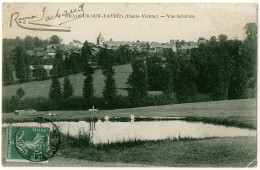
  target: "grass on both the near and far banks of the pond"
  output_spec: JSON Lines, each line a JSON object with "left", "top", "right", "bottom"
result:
{"left": 2, "top": 99, "right": 257, "bottom": 167}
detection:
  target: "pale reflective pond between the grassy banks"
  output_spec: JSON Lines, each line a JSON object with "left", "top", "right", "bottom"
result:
{"left": 3, "top": 120, "right": 256, "bottom": 144}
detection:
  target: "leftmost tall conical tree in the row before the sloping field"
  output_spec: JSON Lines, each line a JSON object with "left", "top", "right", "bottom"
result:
{"left": 49, "top": 75, "right": 63, "bottom": 109}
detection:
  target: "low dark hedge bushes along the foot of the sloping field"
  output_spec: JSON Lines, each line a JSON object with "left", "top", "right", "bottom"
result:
{"left": 2, "top": 94, "right": 179, "bottom": 112}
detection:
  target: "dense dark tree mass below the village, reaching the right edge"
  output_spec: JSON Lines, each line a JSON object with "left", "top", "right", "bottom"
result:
{"left": 2, "top": 23, "right": 257, "bottom": 113}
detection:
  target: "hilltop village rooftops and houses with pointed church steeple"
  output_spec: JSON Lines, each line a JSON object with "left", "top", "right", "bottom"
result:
{"left": 22, "top": 33, "right": 205, "bottom": 78}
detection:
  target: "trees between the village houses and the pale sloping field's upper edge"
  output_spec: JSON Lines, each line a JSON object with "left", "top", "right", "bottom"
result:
{"left": 3, "top": 35, "right": 139, "bottom": 85}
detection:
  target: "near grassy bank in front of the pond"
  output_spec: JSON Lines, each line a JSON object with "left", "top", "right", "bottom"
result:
{"left": 60, "top": 137, "right": 257, "bottom": 167}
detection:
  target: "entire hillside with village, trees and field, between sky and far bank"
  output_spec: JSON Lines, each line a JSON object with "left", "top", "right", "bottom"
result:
{"left": 3, "top": 23, "right": 257, "bottom": 111}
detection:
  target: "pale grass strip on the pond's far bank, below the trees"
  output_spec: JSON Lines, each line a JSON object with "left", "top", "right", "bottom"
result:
{"left": 2, "top": 99, "right": 257, "bottom": 129}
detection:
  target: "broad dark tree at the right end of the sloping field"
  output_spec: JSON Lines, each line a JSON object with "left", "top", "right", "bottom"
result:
{"left": 127, "top": 59, "right": 148, "bottom": 105}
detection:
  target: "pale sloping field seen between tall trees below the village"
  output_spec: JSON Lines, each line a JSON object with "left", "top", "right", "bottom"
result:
{"left": 2, "top": 64, "right": 132, "bottom": 97}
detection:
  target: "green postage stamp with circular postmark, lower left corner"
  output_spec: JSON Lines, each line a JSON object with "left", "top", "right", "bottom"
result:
{"left": 6, "top": 126, "right": 49, "bottom": 162}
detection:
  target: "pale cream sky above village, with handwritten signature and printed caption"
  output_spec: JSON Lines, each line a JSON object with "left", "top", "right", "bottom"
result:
{"left": 2, "top": 3, "right": 257, "bottom": 44}
